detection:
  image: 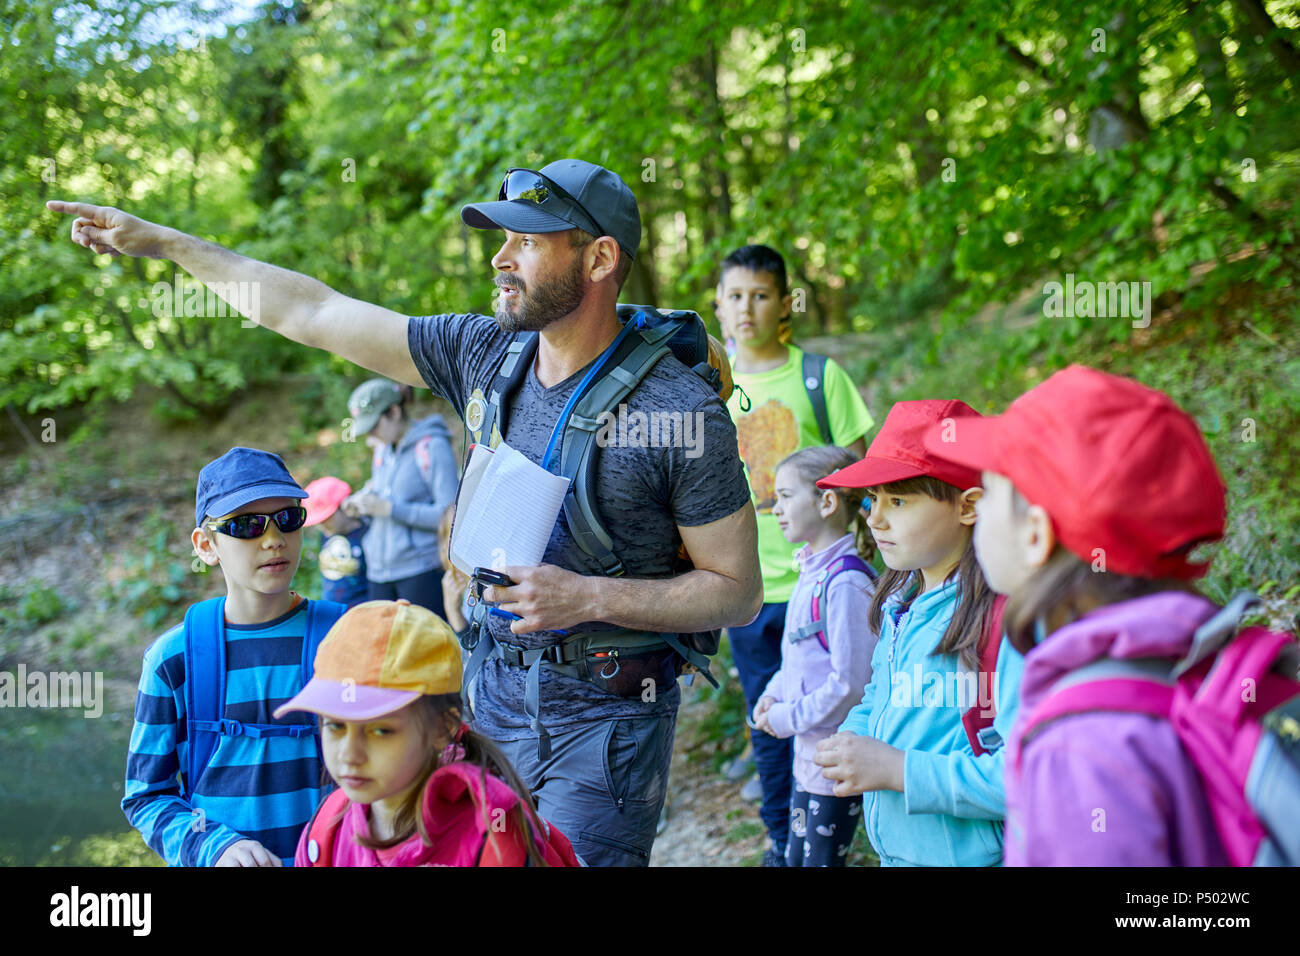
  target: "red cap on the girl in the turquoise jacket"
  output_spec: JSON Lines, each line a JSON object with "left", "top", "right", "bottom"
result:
{"left": 816, "top": 398, "right": 980, "bottom": 490}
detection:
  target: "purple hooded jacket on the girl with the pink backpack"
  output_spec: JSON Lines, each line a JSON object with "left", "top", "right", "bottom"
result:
{"left": 1005, "top": 591, "right": 1227, "bottom": 866}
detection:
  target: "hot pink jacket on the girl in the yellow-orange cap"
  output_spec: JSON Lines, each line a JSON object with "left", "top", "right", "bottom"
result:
{"left": 294, "top": 761, "right": 527, "bottom": 866}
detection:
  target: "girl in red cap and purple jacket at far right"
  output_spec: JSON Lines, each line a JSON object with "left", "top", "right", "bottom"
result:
{"left": 926, "top": 365, "right": 1227, "bottom": 866}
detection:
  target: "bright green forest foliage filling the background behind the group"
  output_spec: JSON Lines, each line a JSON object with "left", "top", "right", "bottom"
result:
{"left": 0, "top": 0, "right": 1300, "bottom": 621}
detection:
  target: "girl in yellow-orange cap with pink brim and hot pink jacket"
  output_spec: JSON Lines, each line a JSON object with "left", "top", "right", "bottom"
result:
{"left": 276, "top": 600, "right": 579, "bottom": 866}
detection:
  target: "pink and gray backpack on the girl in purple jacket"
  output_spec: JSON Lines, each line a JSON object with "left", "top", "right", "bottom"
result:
{"left": 1011, "top": 593, "right": 1300, "bottom": 866}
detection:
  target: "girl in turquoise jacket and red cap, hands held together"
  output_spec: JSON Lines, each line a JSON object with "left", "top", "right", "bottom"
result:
{"left": 815, "top": 401, "right": 1021, "bottom": 866}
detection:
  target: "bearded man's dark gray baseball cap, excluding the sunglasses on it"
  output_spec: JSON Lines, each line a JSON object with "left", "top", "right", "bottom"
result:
{"left": 460, "top": 160, "right": 641, "bottom": 259}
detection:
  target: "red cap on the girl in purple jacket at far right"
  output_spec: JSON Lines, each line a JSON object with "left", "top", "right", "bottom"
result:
{"left": 926, "top": 365, "right": 1227, "bottom": 579}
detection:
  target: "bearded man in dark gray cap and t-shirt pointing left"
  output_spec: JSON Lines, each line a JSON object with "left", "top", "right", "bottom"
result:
{"left": 49, "top": 160, "right": 762, "bottom": 865}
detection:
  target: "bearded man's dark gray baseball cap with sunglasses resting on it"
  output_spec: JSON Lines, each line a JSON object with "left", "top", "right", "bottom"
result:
{"left": 460, "top": 160, "right": 641, "bottom": 259}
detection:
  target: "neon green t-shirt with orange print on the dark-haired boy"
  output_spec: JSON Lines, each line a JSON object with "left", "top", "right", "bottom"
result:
{"left": 727, "top": 345, "right": 875, "bottom": 604}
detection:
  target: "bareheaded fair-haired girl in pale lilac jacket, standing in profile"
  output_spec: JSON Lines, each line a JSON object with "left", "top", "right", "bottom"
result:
{"left": 753, "top": 446, "right": 876, "bottom": 866}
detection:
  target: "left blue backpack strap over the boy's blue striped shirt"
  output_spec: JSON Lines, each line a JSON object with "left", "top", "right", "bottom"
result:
{"left": 185, "top": 597, "right": 226, "bottom": 799}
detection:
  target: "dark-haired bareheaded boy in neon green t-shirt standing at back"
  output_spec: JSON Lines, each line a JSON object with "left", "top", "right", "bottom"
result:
{"left": 718, "top": 246, "right": 874, "bottom": 866}
